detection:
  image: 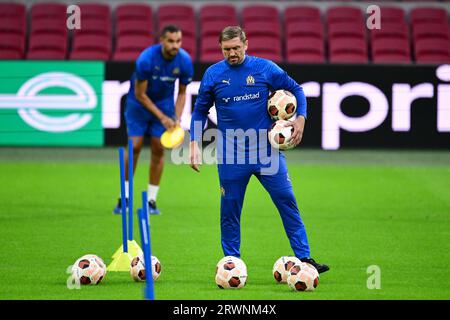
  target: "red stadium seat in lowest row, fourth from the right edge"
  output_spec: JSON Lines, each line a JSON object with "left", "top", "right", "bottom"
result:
{"left": 286, "top": 37, "right": 325, "bottom": 63}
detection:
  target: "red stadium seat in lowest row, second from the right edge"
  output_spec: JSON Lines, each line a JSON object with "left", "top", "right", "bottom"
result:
{"left": 372, "top": 38, "right": 411, "bottom": 63}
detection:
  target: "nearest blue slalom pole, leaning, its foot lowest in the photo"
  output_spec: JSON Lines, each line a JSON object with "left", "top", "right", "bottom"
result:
{"left": 138, "top": 191, "right": 155, "bottom": 300}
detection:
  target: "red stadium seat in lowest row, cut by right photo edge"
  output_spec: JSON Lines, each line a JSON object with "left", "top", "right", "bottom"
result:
{"left": 414, "top": 39, "right": 450, "bottom": 63}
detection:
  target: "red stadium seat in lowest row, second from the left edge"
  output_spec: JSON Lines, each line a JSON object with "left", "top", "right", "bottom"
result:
{"left": 27, "top": 34, "right": 67, "bottom": 60}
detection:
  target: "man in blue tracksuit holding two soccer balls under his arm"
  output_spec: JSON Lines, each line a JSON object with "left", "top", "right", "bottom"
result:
{"left": 189, "top": 26, "right": 329, "bottom": 273}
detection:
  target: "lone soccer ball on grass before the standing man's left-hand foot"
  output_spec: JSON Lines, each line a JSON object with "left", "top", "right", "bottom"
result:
{"left": 216, "top": 256, "right": 247, "bottom": 289}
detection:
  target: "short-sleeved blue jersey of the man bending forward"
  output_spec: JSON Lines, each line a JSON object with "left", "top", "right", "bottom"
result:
{"left": 127, "top": 44, "right": 194, "bottom": 111}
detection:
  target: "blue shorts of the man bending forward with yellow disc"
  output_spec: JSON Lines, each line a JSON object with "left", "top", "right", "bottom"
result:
{"left": 125, "top": 100, "right": 174, "bottom": 138}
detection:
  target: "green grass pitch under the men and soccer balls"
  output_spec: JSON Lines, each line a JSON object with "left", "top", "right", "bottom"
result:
{"left": 0, "top": 148, "right": 450, "bottom": 300}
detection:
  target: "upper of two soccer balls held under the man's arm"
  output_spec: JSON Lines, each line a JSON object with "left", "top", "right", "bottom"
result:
{"left": 267, "top": 90, "right": 297, "bottom": 120}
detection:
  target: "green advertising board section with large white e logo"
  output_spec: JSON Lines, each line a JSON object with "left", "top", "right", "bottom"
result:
{"left": 0, "top": 62, "right": 104, "bottom": 145}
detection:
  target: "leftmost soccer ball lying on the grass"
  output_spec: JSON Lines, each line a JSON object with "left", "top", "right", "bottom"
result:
{"left": 72, "top": 254, "right": 106, "bottom": 285}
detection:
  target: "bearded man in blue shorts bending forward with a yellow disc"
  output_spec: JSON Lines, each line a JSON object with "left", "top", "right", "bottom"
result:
{"left": 114, "top": 25, "right": 194, "bottom": 214}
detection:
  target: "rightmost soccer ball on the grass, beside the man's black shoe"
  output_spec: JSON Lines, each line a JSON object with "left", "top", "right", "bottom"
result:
{"left": 287, "top": 263, "right": 319, "bottom": 291}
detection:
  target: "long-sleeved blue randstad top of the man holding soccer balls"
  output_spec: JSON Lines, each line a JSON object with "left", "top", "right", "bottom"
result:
{"left": 190, "top": 56, "right": 306, "bottom": 162}
